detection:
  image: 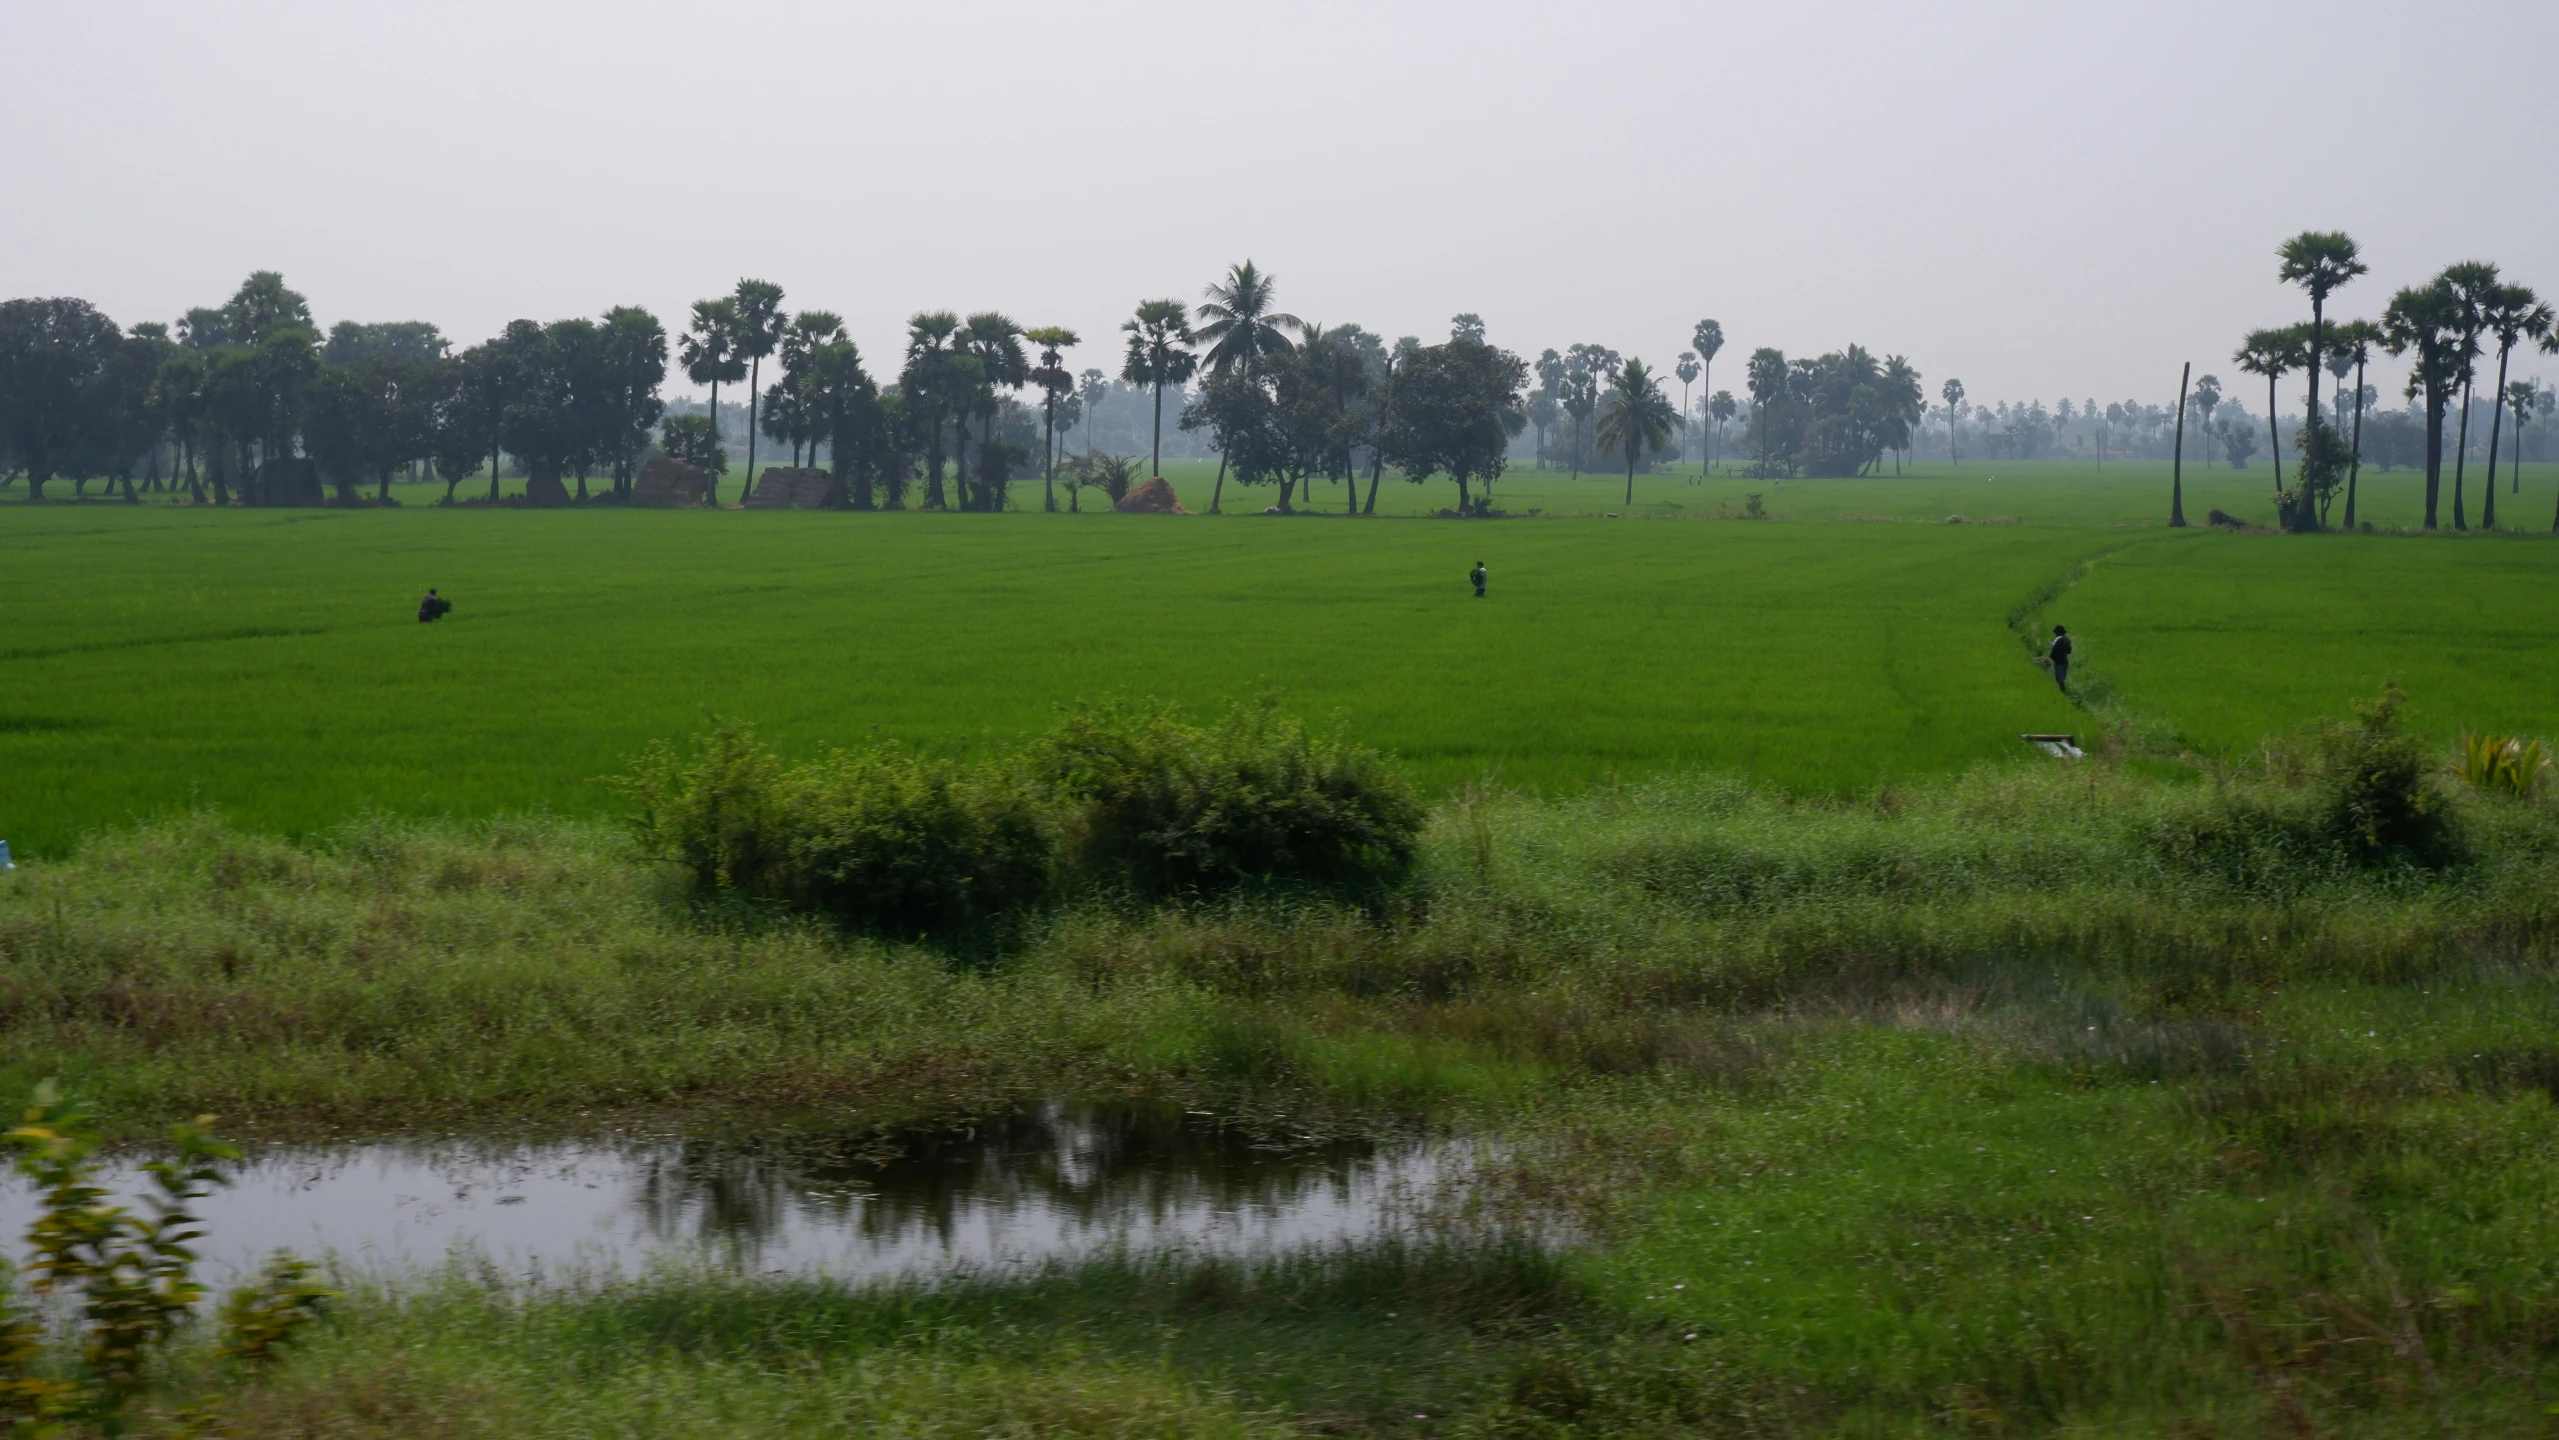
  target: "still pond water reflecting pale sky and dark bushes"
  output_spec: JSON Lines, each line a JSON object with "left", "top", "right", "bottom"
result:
{"left": 0, "top": 1102, "right": 1466, "bottom": 1279}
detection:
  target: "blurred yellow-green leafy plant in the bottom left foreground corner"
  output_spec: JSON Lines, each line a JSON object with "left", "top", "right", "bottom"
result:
{"left": 0, "top": 1082, "right": 333, "bottom": 1435}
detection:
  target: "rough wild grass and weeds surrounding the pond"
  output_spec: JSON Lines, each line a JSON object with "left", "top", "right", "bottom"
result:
{"left": 15, "top": 760, "right": 2559, "bottom": 1437}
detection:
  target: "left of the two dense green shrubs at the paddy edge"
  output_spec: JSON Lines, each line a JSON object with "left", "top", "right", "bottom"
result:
{"left": 619, "top": 726, "right": 1057, "bottom": 939}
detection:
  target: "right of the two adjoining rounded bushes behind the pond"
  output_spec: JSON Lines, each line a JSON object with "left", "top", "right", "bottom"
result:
{"left": 1031, "top": 698, "right": 1428, "bottom": 895}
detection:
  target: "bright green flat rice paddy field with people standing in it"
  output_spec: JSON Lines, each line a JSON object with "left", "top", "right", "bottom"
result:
{"left": 0, "top": 466, "right": 2559, "bottom": 854}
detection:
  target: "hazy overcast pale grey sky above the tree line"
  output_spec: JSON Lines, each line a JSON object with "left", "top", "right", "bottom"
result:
{"left": 0, "top": 0, "right": 2559, "bottom": 402}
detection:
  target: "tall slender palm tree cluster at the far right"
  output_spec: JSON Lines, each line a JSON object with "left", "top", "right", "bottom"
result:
{"left": 2231, "top": 230, "right": 2559, "bottom": 529}
